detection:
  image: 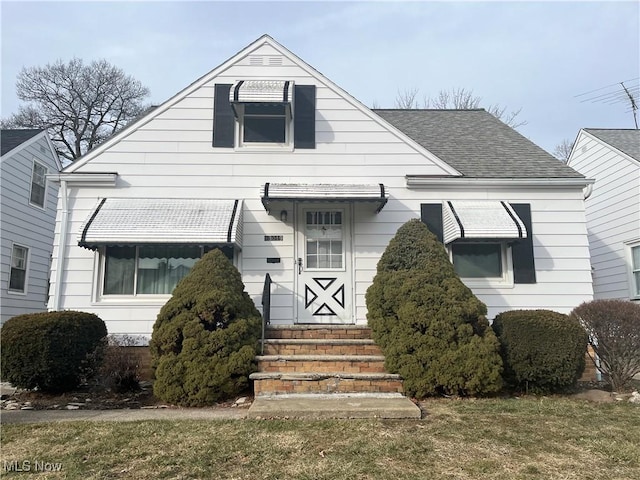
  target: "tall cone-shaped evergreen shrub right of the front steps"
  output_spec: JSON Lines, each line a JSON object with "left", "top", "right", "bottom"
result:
{"left": 366, "top": 220, "right": 502, "bottom": 398}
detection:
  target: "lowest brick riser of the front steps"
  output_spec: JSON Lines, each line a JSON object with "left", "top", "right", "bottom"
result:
{"left": 253, "top": 378, "right": 403, "bottom": 396}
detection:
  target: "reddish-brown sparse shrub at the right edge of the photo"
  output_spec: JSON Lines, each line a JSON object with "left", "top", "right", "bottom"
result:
{"left": 571, "top": 300, "right": 640, "bottom": 392}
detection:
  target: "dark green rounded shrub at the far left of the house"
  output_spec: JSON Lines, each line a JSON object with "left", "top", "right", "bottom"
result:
{"left": 0, "top": 311, "right": 107, "bottom": 392}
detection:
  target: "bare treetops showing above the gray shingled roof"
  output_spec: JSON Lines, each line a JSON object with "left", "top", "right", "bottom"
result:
{"left": 395, "top": 87, "right": 527, "bottom": 128}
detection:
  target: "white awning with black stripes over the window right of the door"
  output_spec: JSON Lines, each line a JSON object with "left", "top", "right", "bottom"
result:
{"left": 442, "top": 200, "right": 527, "bottom": 244}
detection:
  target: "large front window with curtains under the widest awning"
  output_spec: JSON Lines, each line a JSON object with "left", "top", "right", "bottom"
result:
{"left": 103, "top": 245, "right": 233, "bottom": 295}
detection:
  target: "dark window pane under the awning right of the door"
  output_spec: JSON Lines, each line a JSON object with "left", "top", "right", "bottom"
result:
{"left": 451, "top": 243, "right": 504, "bottom": 278}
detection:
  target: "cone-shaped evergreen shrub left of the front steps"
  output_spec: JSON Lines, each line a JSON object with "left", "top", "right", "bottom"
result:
{"left": 150, "top": 249, "right": 261, "bottom": 406}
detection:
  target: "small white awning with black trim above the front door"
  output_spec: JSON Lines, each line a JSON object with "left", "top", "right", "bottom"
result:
{"left": 261, "top": 183, "right": 389, "bottom": 213}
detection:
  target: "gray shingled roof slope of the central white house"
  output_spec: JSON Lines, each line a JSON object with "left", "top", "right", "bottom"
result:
{"left": 374, "top": 109, "right": 584, "bottom": 178}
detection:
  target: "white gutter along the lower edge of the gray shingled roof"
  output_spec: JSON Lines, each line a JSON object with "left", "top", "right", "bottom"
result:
{"left": 405, "top": 175, "right": 595, "bottom": 189}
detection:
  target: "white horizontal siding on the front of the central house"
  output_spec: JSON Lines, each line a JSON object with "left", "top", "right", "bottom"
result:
{"left": 52, "top": 42, "right": 592, "bottom": 338}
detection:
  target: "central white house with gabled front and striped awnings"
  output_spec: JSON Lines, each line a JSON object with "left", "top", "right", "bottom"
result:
{"left": 49, "top": 36, "right": 592, "bottom": 337}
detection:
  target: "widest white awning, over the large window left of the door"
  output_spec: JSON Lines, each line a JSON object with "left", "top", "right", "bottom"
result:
{"left": 78, "top": 198, "right": 242, "bottom": 249}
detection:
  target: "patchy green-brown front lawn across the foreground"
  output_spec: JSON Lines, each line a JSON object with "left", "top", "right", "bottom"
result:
{"left": 0, "top": 397, "right": 640, "bottom": 480}
